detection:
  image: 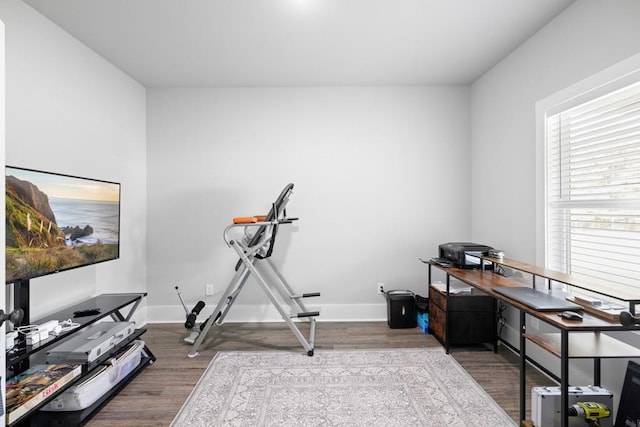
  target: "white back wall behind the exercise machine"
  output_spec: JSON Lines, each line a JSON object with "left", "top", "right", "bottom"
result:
{"left": 147, "top": 87, "right": 469, "bottom": 321}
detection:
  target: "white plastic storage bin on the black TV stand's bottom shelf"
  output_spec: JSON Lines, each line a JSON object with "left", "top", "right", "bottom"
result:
{"left": 40, "top": 340, "right": 145, "bottom": 411}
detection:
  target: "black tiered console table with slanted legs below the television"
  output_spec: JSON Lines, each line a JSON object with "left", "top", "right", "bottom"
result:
{"left": 6, "top": 293, "right": 156, "bottom": 426}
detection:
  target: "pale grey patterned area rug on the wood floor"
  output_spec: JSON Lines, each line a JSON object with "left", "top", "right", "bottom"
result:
{"left": 172, "top": 348, "right": 516, "bottom": 427}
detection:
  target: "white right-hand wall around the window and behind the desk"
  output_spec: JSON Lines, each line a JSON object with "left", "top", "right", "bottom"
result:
{"left": 471, "top": 0, "right": 640, "bottom": 407}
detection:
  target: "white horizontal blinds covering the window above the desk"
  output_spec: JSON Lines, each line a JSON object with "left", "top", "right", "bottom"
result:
{"left": 546, "top": 82, "right": 640, "bottom": 288}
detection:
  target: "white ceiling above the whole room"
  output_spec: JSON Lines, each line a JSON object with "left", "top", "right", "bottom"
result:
{"left": 24, "top": 0, "right": 574, "bottom": 87}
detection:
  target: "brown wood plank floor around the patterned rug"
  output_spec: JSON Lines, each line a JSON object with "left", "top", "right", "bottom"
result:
{"left": 87, "top": 322, "right": 552, "bottom": 427}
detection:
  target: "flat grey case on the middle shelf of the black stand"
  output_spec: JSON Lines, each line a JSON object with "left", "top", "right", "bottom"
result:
{"left": 47, "top": 322, "right": 135, "bottom": 364}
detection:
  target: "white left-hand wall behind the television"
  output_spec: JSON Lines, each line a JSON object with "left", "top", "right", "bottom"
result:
{"left": 0, "top": 0, "right": 146, "bottom": 318}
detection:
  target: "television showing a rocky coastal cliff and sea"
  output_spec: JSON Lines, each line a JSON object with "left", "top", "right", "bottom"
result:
{"left": 5, "top": 166, "right": 120, "bottom": 283}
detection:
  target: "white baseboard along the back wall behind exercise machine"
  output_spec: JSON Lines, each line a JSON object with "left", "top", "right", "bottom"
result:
{"left": 146, "top": 304, "right": 387, "bottom": 323}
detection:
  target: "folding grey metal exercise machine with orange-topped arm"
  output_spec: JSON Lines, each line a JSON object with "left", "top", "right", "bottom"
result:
{"left": 189, "top": 184, "right": 320, "bottom": 357}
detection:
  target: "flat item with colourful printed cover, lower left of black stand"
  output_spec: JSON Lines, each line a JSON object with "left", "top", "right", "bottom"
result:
{"left": 6, "top": 364, "right": 82, "bottom": 424}
